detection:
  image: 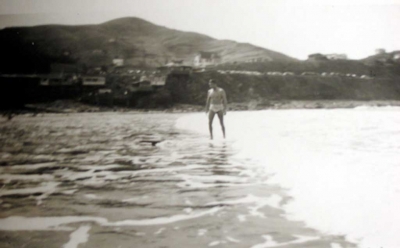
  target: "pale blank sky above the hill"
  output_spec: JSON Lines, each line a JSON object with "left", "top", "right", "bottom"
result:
{"left": 0, "top": 0, "right": 400, "bottom": 59}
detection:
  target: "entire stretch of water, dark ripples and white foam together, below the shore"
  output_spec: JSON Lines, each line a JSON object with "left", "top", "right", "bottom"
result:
{"left": 0, "top": 111, "right": 400, "bottom": 248}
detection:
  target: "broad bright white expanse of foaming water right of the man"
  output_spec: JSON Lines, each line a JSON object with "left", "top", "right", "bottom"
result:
{"left": 176, "top": 107, "right": 400, "bottom": 248}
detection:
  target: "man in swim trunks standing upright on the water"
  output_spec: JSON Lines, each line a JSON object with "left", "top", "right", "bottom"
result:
{"left": 206, "top": 79, "right": 227, "bottom": 139}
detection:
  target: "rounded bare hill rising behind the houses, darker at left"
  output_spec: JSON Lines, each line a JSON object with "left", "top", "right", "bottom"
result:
{"left": 0, "top": 17, "right": 295, "bottom": 73}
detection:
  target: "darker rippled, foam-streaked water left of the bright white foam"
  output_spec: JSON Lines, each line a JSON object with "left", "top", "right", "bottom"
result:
{"left": 0, "top": 113, "right": 356, "bottom": 248}
